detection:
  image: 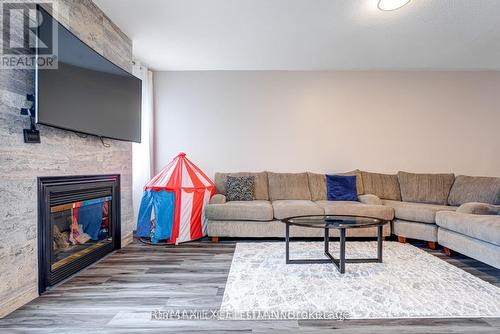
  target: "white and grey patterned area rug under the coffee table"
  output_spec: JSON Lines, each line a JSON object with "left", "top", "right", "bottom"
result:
{"left": 220, "top": 242, "right": 500, "bottom": 319}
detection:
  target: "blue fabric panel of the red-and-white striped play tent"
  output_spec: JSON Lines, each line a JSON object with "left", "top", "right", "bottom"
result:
{"left": 136, "top": 190, "right": 175, "bottom": 243}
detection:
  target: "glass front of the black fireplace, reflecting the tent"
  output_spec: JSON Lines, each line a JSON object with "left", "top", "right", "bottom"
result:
{"left": 50, "top": 196, "right": 113, "bottom": 271}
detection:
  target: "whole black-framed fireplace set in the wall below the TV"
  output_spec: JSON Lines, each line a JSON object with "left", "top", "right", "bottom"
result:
{"left": 38, "top": 175, "right": 121, "bottom": 293}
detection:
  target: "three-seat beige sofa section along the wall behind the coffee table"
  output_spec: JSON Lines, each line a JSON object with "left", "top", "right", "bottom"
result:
{"left": 205, "top": 172, "right": 394, "bottom": 238}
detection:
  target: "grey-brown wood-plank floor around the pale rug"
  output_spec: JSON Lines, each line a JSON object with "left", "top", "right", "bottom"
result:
{"left": 0, "top": 240, "right": 500, "bottom": 334}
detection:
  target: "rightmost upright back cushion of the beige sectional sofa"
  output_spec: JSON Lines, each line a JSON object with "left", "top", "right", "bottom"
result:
{"left": 448, "top": 175, "right": 500, "bottom": 205}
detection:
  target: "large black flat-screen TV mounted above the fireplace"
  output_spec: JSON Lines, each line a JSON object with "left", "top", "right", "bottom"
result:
{"left": 35, "top": 7, "right": 142, "bottom": 142}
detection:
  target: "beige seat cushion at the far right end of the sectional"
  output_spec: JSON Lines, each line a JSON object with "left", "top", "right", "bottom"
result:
{"left": 436, "top": 212, "right": 500, "bottom": 246}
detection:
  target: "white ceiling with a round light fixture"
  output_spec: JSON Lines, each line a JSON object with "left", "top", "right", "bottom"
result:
{"left": 94, "top": 0, "right": 500, "bottom": 70}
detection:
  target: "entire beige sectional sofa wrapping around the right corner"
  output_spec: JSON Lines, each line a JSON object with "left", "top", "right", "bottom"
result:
{"left": 205, "top": 170, "right": 500, "bottom": 268}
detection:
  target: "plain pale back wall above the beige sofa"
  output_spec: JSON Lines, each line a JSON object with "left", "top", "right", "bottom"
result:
{"left": 155, "top": 71, "right": 500, "bottom": 177}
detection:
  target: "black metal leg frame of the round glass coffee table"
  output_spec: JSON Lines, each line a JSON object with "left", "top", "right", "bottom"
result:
{"left": 285, "top": 221, "right": 387, "bottom": 274}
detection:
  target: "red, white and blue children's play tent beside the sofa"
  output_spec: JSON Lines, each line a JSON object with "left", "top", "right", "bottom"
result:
{"left": 137, "top": 153, "right": 215, "bottom": 244}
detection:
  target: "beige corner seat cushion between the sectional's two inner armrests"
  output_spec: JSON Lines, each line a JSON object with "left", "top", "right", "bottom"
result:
{"left": 382, "top": 200, "right": 457, "bottom": 224}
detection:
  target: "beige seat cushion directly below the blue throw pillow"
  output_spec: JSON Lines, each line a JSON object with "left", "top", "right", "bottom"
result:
{"left": 316, "top": 201, "right": 394, "bottom": 220}
